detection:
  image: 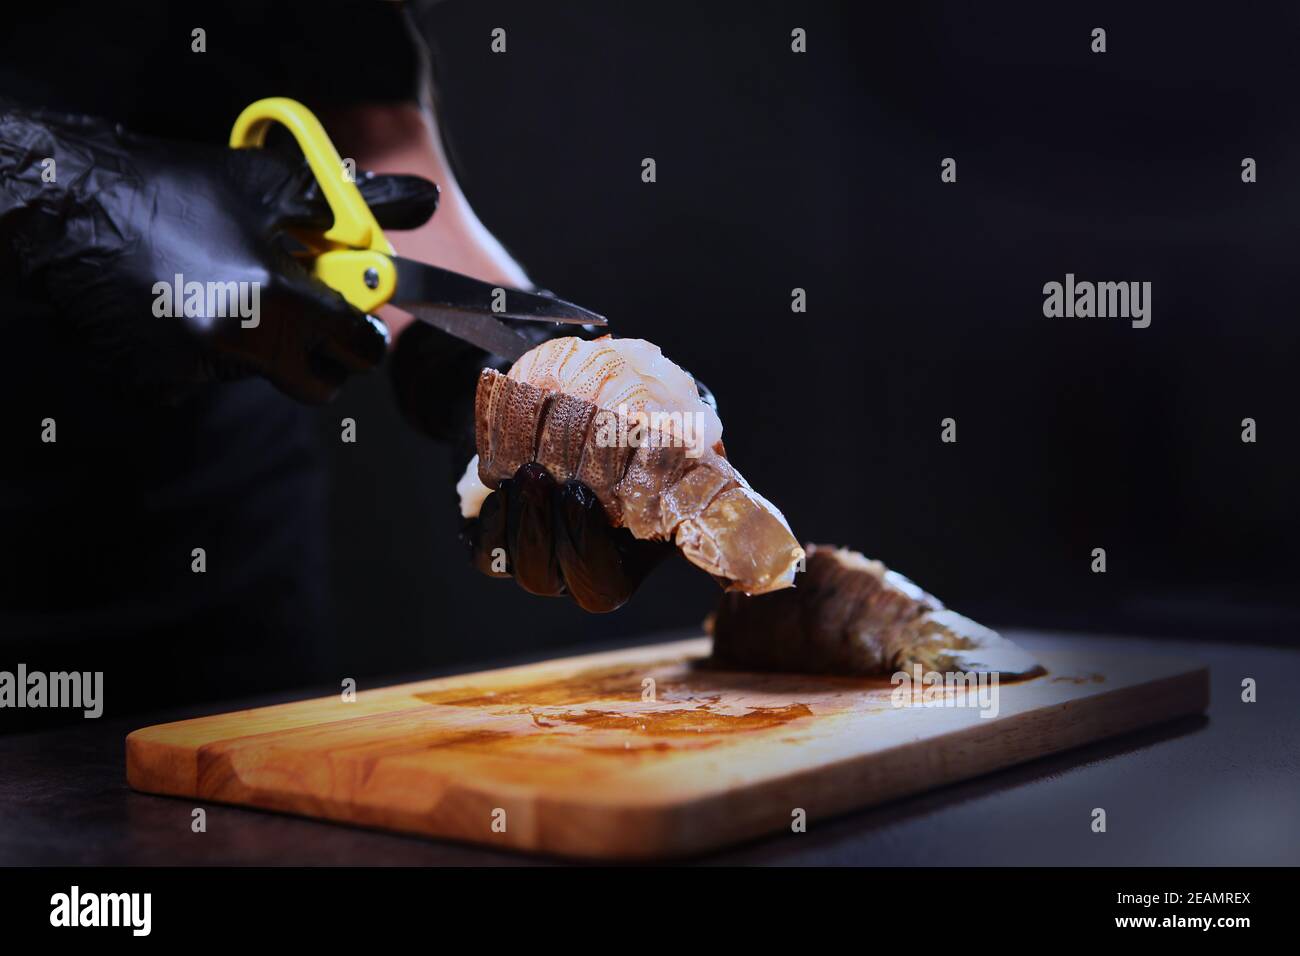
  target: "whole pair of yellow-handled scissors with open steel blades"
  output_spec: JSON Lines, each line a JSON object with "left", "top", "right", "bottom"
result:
{"left": 230, "top": 96, "right": 607, "bottom": 362}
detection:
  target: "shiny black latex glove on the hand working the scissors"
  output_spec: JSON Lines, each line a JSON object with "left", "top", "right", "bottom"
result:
{"left": 0, "top": 107, "right": 438, "bottom": 402}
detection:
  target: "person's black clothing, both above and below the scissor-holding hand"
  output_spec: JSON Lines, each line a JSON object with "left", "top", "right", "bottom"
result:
{"left": 0, "top": 1, "right": 416, "bottom": 727}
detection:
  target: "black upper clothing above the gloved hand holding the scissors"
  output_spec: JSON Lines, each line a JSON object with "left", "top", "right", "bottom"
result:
{"left": 0, "top": 0, "right": 417, "bottom": 143}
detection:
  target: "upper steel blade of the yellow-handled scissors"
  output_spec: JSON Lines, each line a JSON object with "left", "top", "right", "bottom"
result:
{"left": 393, "top": 256, "right": 607, "bottom": 327}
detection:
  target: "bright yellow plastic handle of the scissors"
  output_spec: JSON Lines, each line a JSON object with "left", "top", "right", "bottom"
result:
{"left": 230, "top": 96, "right": 398, "bottom": 312}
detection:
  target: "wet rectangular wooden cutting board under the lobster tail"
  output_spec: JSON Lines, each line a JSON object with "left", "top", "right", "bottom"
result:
{"left": 126, "top": 637, "right": 1209, "bottom": 858}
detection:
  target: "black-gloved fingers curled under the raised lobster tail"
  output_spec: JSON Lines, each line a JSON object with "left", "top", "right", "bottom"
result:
{"left": 463, "top": 463, "right": 673, "bottom": 614}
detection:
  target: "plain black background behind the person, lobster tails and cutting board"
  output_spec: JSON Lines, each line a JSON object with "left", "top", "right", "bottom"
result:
{"left": 324, "top": 3, "right": 1300, "bottom": 669}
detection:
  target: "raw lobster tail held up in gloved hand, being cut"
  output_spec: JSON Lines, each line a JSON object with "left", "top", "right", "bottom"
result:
{"left": 462, "top": 337, "right": 803, "bottom": 594}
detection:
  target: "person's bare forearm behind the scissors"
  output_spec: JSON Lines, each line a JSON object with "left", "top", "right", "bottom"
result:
{"left": 328, "top": 103, "right": 532, "bottom": 341}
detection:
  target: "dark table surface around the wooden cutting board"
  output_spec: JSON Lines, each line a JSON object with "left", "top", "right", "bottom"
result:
{"left": 0, "top": 632, "right": 1300, "bottom": 865}
